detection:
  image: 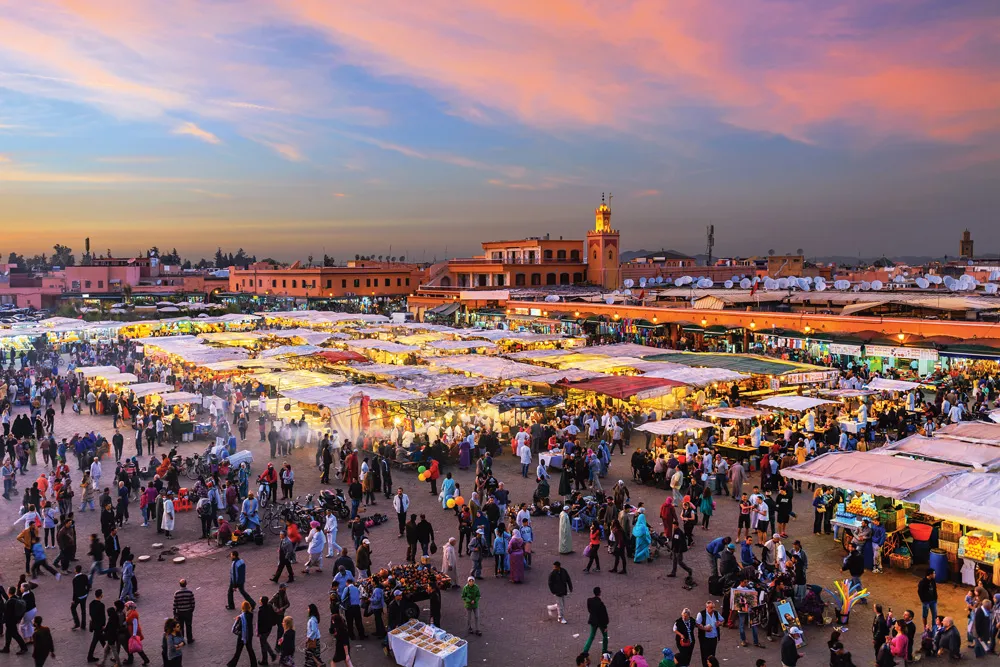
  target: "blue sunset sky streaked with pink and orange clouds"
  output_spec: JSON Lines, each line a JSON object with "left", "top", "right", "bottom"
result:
{"left": 0, "top": 0, "right": 1000, "bottom": 260}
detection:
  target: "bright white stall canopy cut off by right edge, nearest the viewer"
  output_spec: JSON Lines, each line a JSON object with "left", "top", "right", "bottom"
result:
{"left": 920, "top": 472, "right": 1000, "bottom": 532}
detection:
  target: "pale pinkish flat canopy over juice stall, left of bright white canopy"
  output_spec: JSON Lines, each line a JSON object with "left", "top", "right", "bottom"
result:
{"left": 781, "top": 452, "right": 963, "bottom": 500}
